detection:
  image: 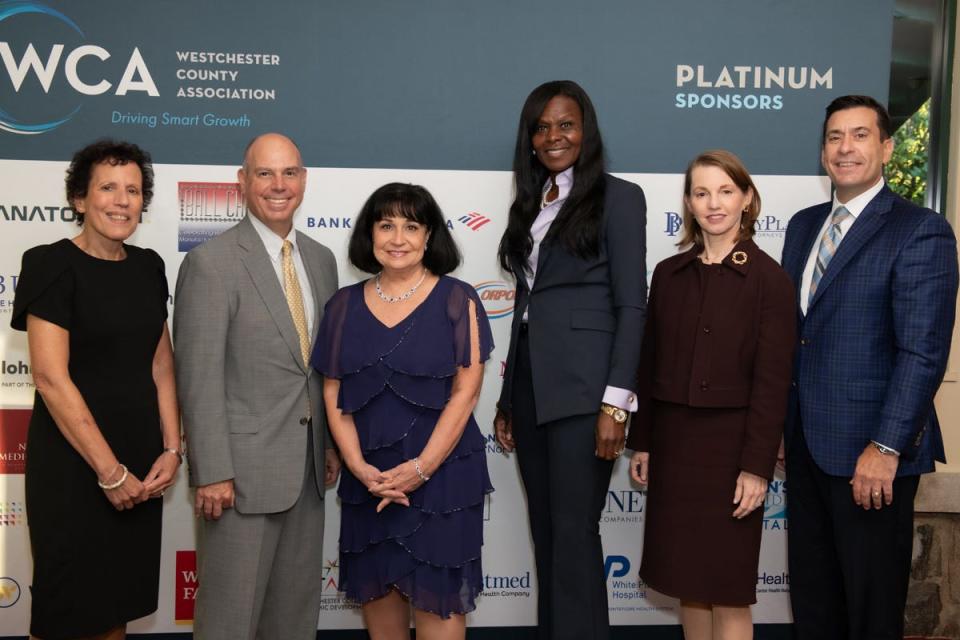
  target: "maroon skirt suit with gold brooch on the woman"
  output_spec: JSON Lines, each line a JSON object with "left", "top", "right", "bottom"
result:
{"left": 627, "top": 240, "right": 796, "bottom": 606}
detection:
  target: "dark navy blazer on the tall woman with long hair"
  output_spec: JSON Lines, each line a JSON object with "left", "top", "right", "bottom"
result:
{"left": 497, "top": 175, "right": 647, "bottom": 424}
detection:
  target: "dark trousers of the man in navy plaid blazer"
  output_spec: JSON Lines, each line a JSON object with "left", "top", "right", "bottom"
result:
{"left": 787, "top": 425, "right": 919, "bottom": 640}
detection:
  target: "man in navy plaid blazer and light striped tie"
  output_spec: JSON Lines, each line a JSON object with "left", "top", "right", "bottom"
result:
{"left": 782, "top": 96, "right": 957, "bottom": 640}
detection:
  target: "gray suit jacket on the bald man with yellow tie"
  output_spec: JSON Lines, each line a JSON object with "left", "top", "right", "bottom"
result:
{"left": 173, "top": 218, "right": 337, "bottom": 513}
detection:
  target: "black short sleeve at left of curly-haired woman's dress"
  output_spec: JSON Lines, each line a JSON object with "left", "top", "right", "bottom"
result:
{"left": 10, "top": 240, "right": 76, "bottom": 331}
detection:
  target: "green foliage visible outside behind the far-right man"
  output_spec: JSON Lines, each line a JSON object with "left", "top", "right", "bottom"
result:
{"left": 886, "top": 99, "right": 930, "bottom": 205}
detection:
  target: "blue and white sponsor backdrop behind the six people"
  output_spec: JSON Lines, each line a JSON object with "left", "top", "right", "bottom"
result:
{"left": 0, "top": 0, "right": 892, "bottom": 636}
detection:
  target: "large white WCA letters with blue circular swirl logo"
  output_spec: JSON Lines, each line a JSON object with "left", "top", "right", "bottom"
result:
{"left": 0, "top": 0, "right": 160, "bottom": 135}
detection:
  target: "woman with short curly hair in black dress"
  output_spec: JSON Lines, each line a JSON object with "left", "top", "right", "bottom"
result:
{"left": 11, "top": 140, "right": 181, "bottom": 640}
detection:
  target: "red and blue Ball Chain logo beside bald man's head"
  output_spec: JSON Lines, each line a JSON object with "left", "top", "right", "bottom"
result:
{"left": 177, "top": 182, "right": 246, "bottom": 251}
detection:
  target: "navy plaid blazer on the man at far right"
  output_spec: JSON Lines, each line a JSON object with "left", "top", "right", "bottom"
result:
{"left": 782, "top": 186, "right": 958, "bottom": 477}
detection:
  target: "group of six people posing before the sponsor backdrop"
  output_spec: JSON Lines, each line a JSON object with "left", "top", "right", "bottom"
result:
{"left": 12, "top": 81, "right": 958, "bottom": 640}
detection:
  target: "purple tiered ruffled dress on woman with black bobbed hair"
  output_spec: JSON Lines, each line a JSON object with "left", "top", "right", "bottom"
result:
{"left": 312, "top": 276, "right": 493, "bottom": 618}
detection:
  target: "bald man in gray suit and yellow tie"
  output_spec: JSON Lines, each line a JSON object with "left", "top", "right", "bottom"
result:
{"left": 173, "top": 133, "right": 339, "bottom": 640}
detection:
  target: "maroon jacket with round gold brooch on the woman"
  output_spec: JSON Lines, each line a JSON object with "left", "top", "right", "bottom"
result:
{"left": 627, "top": 240, "right": 797, "bottom": 478}
